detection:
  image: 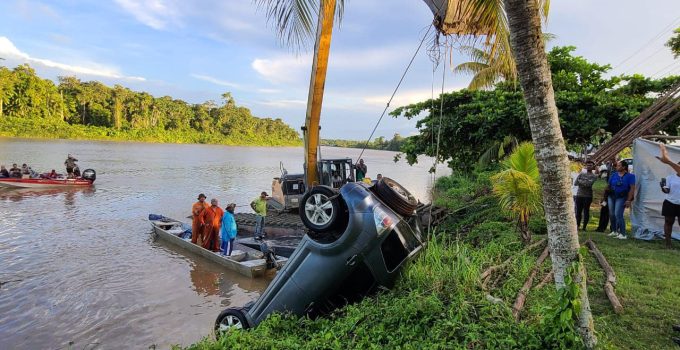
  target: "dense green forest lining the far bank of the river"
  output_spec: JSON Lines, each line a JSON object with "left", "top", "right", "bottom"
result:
{"left": 0, "top": 65, "right": 300, "bottom": 145}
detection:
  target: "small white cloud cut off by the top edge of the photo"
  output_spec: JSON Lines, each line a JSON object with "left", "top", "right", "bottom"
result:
{"left": 116, "top": 0, "right": 179, "bottom": 30}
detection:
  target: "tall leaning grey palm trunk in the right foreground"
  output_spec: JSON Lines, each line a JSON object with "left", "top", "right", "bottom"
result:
{"left": 504, "top": 0, "right": 597, "bottom": 349}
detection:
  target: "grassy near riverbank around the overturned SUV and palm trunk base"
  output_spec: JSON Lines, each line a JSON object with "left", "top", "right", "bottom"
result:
{"left": 189, "top": 176, "right": 680, "bottom": 349}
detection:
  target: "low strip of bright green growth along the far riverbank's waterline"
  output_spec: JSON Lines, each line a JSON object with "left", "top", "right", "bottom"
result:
{"left": 0, "top": 116, "right": 302, "bottom": 146}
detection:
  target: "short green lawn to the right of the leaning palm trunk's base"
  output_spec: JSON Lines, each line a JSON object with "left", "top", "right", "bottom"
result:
{"left": 582, "top": 232, "right": 680, "bottom": 349}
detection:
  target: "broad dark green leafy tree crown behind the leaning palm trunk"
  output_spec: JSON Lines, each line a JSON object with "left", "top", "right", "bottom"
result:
{"left": 391, "top": 47, "right": 680, "bottom": 170}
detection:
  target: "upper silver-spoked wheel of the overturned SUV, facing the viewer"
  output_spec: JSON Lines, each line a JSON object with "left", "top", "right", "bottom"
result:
{"left": 300, "top": 186, "right": 343, "bottom": 233}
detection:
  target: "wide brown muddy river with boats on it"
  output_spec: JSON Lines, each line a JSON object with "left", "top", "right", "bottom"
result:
{"left": 0, "top": 138, "right": 448, "bottom": 349}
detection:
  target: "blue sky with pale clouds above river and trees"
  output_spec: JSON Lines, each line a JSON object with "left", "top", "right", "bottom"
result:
{"left": 0, "top": 0, "right": 680, "bottom": 140}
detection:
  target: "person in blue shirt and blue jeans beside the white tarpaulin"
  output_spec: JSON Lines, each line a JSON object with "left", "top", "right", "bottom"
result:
{"left": 606, "top": 160, "right": 635, "bottom": 239}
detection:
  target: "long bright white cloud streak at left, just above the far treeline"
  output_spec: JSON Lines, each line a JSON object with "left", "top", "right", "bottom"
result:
{"left": 0, "top": 36, "right": 146, "bottom": 81}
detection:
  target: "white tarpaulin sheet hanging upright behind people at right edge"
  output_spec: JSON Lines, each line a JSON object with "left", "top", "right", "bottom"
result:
{"left": 630, "top": 139, "right": 680, "bottom": 240}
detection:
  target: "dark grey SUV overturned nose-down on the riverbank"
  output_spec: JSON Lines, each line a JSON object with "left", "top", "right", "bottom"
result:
{"left": 215, "top": 178, "right": 423, "bottom": 336}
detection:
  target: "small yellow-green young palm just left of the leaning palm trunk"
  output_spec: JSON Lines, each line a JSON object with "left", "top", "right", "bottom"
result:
{"left": 491, "top": 142, "right": 541, "bottom": 243}
